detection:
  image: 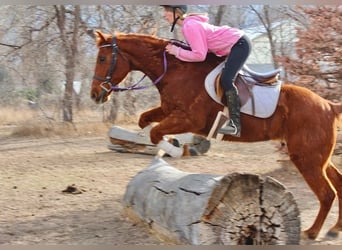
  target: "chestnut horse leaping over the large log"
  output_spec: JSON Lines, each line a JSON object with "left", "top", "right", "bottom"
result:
{"left": 90, "top": 31, "right": 342, "bottom": 239}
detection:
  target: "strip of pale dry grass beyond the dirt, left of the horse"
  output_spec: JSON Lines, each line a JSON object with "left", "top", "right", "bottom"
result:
{"left": 0, "top": 108, "right": 137, "bottom": 138}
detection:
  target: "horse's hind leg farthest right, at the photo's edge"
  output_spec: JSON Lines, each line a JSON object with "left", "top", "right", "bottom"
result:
{"left": 326, "top": 162, "right": 342, "bottom": 237}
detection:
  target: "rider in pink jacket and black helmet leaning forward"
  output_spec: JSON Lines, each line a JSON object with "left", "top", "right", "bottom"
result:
{"left": 162, "top": 5, "right": 251, "bottom": 137}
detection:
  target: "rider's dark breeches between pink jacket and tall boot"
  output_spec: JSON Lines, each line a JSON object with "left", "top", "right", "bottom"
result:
{"left": 220, "top": 36, "right": 252, "bottom": 92}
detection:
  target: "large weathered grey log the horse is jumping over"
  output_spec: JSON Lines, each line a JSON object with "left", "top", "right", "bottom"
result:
{"left": 123, "top": 159, "right": 300, "bottom": 245}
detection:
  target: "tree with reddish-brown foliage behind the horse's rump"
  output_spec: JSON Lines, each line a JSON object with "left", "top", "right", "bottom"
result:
{"left": 277, "top": 6, "right": 342, "bottom": 101}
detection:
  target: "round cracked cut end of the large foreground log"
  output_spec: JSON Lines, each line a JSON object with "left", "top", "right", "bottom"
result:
{"left": 203, "top": 173, "right": 300, "bottom": 245}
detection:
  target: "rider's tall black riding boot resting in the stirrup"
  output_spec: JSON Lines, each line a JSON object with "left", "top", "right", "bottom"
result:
{"left": 218, "top": 87, "right": 241, "bottom": 137}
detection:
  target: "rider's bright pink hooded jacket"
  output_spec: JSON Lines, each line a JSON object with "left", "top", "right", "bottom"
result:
{"left": 175, "top": 15, "right": 244, "bottom": 62}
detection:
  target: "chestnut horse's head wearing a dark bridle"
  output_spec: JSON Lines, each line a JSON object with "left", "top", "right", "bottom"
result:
{"left": 90, "top": 31, "right": 131, "bottom": 103}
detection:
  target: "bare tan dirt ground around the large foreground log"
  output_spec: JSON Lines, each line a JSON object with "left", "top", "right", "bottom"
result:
{"left": 0, "top": 126, "right": 342, "bottom": 245}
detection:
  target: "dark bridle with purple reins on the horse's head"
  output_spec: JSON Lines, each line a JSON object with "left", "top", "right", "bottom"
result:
{"left": 93, "top": 36, "right": 167, "bottom": 93}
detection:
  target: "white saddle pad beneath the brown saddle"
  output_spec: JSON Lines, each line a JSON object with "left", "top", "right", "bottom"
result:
{"left": 205, "top": 62, "right": 282, "bottom": 118}
